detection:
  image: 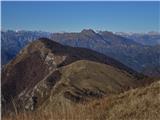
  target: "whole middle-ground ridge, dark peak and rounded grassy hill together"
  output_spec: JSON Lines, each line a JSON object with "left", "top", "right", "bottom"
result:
{"left": 2, "top": 38, "right": 144, "bottom": 114}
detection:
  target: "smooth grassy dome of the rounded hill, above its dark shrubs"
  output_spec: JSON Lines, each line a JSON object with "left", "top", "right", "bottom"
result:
{"left": 60, "top": 60, "right": 137, "bottom": 98}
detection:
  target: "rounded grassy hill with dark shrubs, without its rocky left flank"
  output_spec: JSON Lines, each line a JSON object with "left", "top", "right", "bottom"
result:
{"left": 38, "top": 60, "right": 138, "bottom": 108}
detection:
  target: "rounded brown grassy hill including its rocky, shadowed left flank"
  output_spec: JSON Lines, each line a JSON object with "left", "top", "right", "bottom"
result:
{"left": 16, "top": 60, "right": 139, "bottom": 112}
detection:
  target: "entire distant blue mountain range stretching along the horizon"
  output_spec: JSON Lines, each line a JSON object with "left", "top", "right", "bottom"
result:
{"left": 1, "top": 29, "right": 160, "bottom": 76}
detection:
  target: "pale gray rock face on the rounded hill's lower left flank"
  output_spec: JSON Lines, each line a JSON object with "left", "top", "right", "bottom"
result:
{"left": 21, "top": 70, "right": 60, "bottom": 111}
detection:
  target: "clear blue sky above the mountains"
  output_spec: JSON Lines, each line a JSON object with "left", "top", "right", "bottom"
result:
{"left": 1, "top": 1, "right": 160, "bottom": 32}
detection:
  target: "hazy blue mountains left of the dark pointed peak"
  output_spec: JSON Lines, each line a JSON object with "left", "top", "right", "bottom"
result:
{"left": 1, "top": 30, "right": 50, "bottom": 65}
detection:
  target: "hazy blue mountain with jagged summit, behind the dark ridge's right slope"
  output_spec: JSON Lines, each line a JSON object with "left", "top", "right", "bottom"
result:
{"left": 52, "top": 29, "right": 160, "bottom": 76}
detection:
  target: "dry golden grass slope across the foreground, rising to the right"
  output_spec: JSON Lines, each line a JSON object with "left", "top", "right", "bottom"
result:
{"left": 2, "top": 81, "right": 160, "bottom": 120}
